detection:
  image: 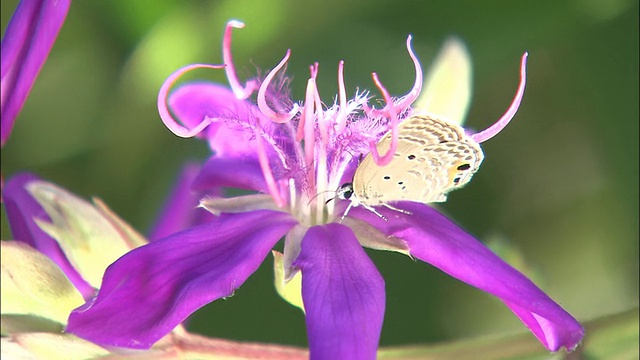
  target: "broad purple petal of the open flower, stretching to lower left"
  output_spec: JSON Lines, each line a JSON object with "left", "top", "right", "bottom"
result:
{"left": 67, "top": 210, "right": 295, "bottom": 349}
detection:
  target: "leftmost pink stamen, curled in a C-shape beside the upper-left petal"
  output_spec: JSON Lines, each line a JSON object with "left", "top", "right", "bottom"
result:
{"left": 158, "top": 64, "right": 224, "bottom": 138}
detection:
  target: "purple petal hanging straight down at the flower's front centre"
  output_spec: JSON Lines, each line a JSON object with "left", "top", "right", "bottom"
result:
{"left": 293, "top": 223, "right": 385, "bottom": 359}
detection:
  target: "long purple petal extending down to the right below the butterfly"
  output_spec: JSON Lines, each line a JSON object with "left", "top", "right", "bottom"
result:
{"left": 350, "top": 202, "right": 584, "bottom": 351}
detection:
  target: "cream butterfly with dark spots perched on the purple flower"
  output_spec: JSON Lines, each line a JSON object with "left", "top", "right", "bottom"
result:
{"left": 337, "top": 114, "right": 484, "bottom": 221}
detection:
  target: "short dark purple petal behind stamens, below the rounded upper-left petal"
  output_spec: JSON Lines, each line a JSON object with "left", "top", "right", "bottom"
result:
{"left": 193, "top": 155, "right": 269, "bottom": 194}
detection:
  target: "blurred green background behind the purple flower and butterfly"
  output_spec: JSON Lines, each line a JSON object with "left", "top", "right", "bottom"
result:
{"left": 1, "top": 0, "right": 639, "bottom": 346}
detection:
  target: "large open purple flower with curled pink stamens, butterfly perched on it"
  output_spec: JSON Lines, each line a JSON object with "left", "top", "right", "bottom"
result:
{"left": 67, "top": 21, "right": 584, "bottom": 359}
